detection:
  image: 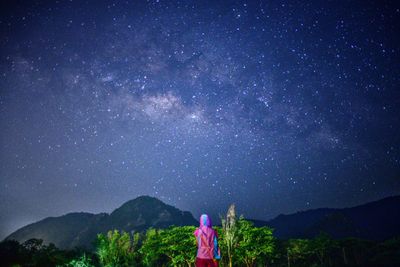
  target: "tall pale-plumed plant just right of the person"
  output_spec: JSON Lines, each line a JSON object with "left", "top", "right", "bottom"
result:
{"left": 221, "top": 204, "right": 237, "bottom": 267}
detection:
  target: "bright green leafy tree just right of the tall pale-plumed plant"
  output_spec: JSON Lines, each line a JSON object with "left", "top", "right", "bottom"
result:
{"left": 236, "top": 220, "right": 274, "bottom": 267}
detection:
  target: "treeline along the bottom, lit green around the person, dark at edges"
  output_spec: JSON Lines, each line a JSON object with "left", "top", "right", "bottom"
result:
{"left": 0, "top": 206, "right": 400, "bottom": 267}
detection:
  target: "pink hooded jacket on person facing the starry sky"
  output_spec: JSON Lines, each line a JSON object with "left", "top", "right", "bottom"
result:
{"left": 194, "top": 214, "right": 219, "bottom": 259}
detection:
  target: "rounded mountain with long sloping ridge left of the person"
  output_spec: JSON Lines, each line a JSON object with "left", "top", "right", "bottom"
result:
{"left": 6, "top": 196, "right": 198, "bottom": 249}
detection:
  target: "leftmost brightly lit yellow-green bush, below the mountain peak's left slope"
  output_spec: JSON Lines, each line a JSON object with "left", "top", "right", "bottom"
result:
{"left": 97, "top": 230, "right": 136, "bottom": 267}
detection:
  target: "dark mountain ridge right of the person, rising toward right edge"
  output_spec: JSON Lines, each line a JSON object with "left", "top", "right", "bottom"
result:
{"left": 253, "top": 196, "right": 400, "bottom": 240}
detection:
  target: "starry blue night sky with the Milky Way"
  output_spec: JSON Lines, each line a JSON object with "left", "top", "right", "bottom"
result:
{"left": 0, "top": 0, "right": 400, "bottom": 241}
